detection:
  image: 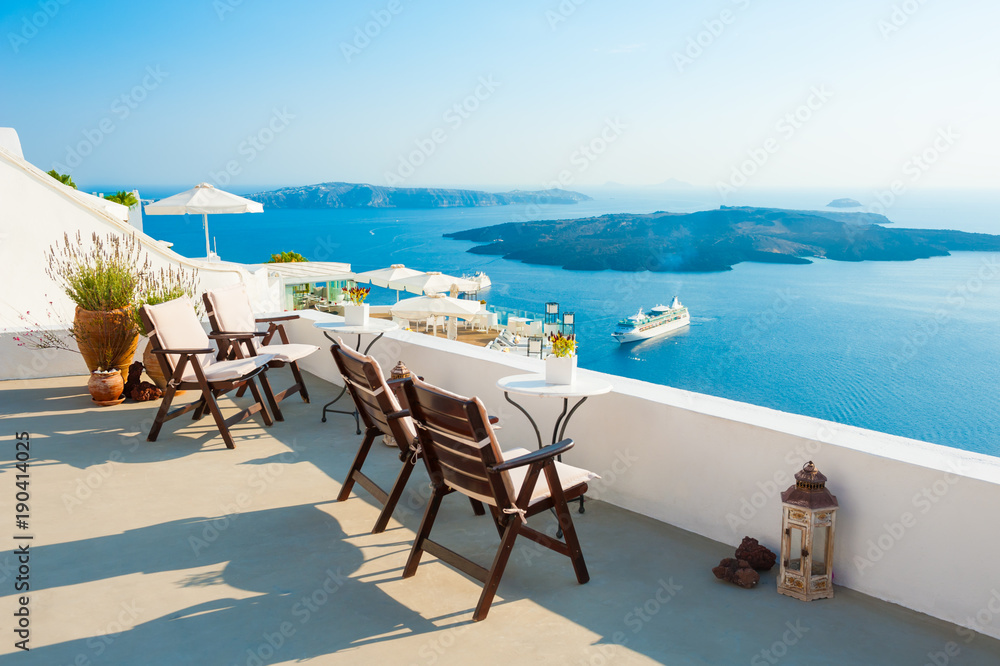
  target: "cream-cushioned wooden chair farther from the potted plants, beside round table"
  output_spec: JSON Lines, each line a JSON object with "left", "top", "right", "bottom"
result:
{"left": 202, "top": 282, "right": 319, "bottom": 421}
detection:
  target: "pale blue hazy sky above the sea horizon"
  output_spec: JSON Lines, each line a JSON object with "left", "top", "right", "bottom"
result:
{"left": 0, "top": 0, "right": 1000, "bottom": 191}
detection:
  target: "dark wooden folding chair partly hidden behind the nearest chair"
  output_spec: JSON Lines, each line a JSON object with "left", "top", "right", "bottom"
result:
{"left": 330, "top": 343, "right": 486, "bottom": 534}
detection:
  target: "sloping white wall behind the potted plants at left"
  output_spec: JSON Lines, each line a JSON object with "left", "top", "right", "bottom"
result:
{"left": 0, "top": 140, "right": 280, "bottom": 379}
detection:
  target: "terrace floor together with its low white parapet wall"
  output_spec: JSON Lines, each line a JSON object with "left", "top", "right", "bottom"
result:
{"left": 0, "top": 313, "right": 1000, "bottom": 665}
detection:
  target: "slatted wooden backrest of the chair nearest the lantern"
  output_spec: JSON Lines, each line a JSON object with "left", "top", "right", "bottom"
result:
{"left": 405, "top": 377, "right": 514, "bottom": 507}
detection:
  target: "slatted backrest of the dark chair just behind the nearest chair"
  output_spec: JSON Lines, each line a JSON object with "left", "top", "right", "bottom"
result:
{"left": 331, "top": 342, "right": 416, "bottom": 453}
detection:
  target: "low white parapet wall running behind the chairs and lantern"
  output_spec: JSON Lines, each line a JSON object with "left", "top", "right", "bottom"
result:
{"left": 290, "top": 312, "right": 1000, "bottom": 644}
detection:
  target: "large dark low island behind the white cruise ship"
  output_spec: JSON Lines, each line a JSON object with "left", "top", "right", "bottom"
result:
{"left": 445, "top": 206, "right": 1000, "bottom": 272}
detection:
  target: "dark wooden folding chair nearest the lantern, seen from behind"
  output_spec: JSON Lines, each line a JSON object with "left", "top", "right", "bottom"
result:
{"left": 403, "top": 379, "right": 597, "bottom": 621}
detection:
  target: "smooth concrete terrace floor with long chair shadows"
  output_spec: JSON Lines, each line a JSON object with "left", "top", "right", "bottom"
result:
{"left": 0, "top": 376, "right": 1000, "bottom": 666}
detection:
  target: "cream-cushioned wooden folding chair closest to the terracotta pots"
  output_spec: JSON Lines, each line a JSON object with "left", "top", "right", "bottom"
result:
{"left": 139, "top": 296, "right": 274, "bottom": 449}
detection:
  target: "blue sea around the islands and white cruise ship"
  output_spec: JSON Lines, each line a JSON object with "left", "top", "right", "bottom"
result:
{"left": 133, "top": 187, "right": 1000, "bottom": 455}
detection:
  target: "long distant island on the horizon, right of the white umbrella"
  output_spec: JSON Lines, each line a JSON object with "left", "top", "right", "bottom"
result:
{"left": 244, "top": 183, "right": 590, "bottom": 208}
